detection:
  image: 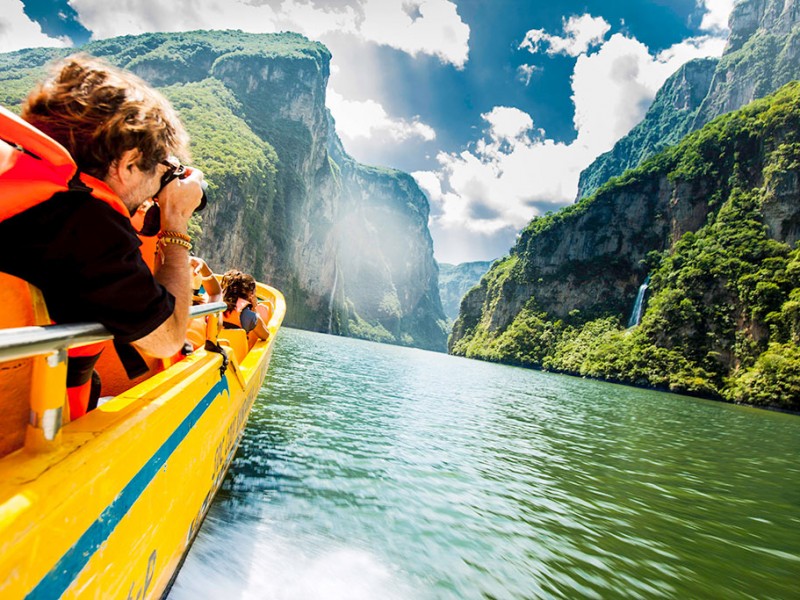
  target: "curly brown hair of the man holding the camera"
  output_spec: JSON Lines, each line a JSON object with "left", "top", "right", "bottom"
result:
{"left": 21, "top": 54, "right": 189, "bottom": 179}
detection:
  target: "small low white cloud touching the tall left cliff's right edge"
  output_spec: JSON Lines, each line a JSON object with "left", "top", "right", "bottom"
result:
{"left": 327, "top": 88, "right": 436, "bottom": 145}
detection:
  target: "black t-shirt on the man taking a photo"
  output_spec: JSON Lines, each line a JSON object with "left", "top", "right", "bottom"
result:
{"left": 0, "top": 192, "right": 175, "bottom": 343}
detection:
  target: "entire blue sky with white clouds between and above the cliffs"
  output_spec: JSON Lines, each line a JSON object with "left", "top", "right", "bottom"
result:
{"left": 0, "top": 0, "right": 734, "bottom": 263}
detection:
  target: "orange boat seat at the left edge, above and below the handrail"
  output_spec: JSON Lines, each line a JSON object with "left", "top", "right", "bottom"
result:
{"left": 0, "top": 273, "right": 50, "bottom": 456}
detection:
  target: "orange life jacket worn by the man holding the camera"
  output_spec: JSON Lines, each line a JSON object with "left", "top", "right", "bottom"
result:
{"left": 0, "top": 106, "right": 130, "bottom": 419}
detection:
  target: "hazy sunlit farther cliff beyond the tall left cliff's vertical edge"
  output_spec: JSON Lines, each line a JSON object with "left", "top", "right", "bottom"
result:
{"left": 329, "top": 125, "right": 446, "bottom": 350}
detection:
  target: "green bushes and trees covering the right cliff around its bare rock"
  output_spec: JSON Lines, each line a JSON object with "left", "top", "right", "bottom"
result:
{"left": 451, "top": 82, "right": 800, "bottom": 410}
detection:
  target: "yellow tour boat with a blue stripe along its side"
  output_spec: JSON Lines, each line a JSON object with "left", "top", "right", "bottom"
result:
{"left": 0, "top": 276, "right": 285, "bottom": 599}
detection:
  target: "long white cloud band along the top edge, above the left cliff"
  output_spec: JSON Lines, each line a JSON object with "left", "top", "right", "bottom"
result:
{"left": 70, "top": 0, "right": 470, "bottom": 68}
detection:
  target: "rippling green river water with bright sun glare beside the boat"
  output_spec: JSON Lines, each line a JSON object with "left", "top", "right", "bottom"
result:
{"left": 170, "top": 330, "right": 800, "bottom": 600}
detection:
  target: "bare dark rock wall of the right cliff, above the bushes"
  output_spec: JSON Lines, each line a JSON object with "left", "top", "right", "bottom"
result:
{"left": 450, "top": 171, "right": 688, "bottom": 350}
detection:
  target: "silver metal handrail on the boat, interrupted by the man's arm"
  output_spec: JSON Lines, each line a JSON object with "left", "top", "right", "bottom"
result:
{"left": 0, "top": 302, "right": 227, "bottom": 362}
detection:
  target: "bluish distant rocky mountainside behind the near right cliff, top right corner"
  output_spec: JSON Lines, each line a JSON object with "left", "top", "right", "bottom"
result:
{"left": 578, "top": 0, "right": 800, "bottom": 199}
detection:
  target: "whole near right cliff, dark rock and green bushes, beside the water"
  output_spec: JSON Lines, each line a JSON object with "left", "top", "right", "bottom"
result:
{"left": 449, "top": 82, "right": 800, "bottom": 410}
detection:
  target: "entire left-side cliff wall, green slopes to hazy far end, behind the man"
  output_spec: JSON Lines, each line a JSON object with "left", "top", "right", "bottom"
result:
{"left": 0, "top": 32, "right": 447, "bottom": 350}
